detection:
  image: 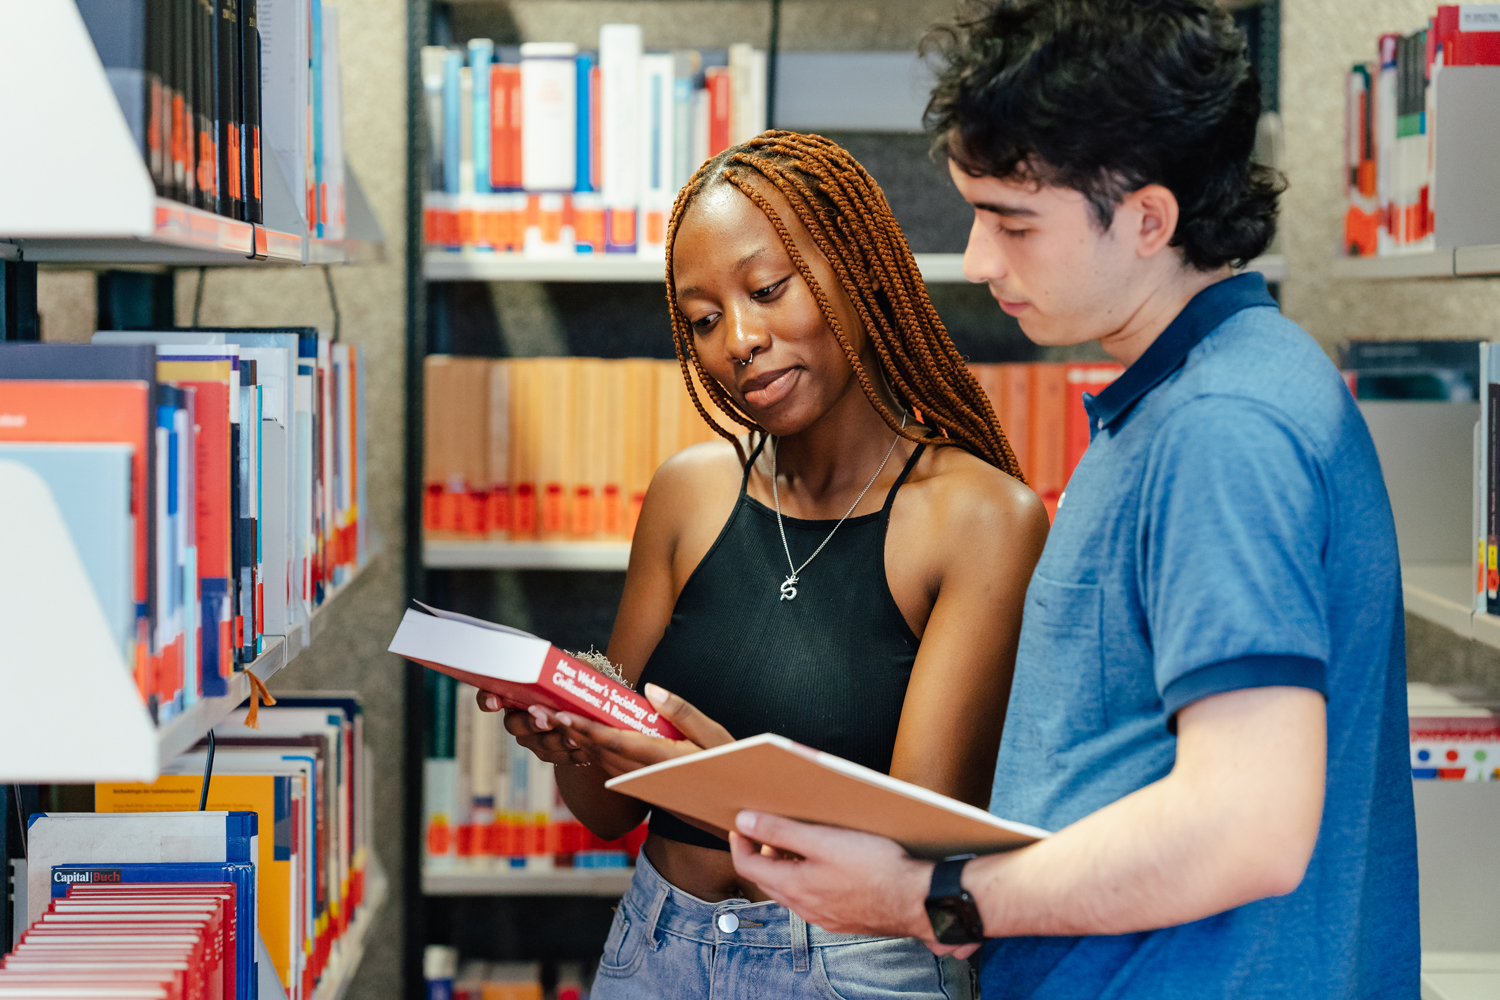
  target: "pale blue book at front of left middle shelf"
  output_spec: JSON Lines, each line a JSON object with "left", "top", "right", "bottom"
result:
{"left": 0, "top": 441, "right": 135, "bottom": 670}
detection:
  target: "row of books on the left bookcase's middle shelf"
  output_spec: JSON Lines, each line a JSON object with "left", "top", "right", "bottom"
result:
{"left": 0, "top": 334, "right": 368, "bottom": 723}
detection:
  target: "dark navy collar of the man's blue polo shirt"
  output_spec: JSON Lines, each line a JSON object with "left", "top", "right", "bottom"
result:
{"left": 1083, "top": 271, "right": 1277, "bottom": 430}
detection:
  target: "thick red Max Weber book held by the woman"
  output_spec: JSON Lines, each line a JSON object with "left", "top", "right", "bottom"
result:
{"left": 390, "top": 601, "right": 683, "bottom": 739}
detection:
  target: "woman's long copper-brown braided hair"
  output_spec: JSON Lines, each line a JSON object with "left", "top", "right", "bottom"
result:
{"left": 666, "top": 132, "right": 1026, "bottom": 483}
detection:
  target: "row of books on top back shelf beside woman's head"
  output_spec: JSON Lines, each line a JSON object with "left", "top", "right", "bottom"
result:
{"left": 422, "top": 24, "right": 767, "bottom": 256}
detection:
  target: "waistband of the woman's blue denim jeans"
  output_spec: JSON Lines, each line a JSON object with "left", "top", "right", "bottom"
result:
{"left": 621, "top": 852, "right": 890, "bottom": 966}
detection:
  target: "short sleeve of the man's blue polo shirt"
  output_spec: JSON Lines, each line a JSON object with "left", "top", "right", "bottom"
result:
{"left": 1137, "top": 396, "right": 1331, "bottom": 720}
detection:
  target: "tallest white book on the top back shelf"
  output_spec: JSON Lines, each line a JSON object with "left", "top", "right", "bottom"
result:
{"left": 599, "top": 24, "right": 641, "bottom": 253}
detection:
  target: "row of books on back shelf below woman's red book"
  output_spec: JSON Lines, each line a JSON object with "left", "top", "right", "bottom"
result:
{"left": 422, "top": 681, "right": 647, "bottom": 871}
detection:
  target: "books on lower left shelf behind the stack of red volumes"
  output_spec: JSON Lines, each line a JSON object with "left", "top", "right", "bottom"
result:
{"left": 18, "top": 691, "right": 372, "bottom": 1000}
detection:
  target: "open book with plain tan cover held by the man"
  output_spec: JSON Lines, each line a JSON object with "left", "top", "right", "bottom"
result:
{"left": 605, "top": 733, "right": 1047, "bottom": 859}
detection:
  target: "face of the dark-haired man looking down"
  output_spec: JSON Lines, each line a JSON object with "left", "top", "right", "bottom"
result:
{"left": 948, "top": 160, "right": 1143, "bottom": 346}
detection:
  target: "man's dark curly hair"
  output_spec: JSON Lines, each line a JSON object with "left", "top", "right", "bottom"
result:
{"left": 923, "top": 0, "right": 1286, "bottom": 271}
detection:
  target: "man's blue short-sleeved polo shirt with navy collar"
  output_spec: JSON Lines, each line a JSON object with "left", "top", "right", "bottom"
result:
{"left": 981, "top": 274, "right": 1419, "bottom": 1000}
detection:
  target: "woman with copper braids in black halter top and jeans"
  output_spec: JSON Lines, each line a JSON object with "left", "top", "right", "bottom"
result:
{"left": 480, "top": 132, "right": 1047, "bottom": 1000}
